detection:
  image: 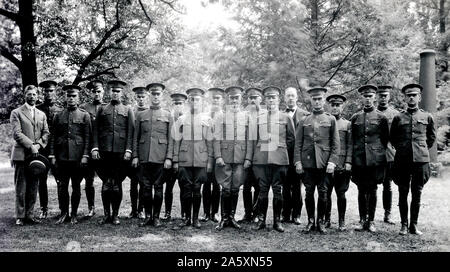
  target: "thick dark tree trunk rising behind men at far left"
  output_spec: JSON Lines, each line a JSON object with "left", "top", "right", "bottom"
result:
{"left": 17, "top": 0, "right": 38, "bottom": 87}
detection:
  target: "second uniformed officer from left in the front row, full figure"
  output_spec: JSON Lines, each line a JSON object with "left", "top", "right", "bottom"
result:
{"left": 91, "top": 80, "right": 134, "bottom": 225}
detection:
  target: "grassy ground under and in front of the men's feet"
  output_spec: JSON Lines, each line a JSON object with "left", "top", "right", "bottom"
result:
{"left": 0, "top": 169, "right": 450, "bottom": 252}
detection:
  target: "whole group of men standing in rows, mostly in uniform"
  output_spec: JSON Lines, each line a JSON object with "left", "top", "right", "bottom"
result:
{"left": 11, "top": 80, "right": 436, "bottom": 235}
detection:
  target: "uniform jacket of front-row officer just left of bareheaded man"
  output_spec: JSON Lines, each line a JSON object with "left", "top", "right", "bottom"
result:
{"left": 247, "top": 110, "right": 295, "bottom": 165}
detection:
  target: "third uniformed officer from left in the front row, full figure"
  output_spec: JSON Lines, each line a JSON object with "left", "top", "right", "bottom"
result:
{"left": 132, "top": 83, "right": 173, "bottom": 227}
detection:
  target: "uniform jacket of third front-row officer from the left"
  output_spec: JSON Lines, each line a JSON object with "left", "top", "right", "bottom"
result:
{"left": 133, "top": 107, "right": 173, "bottom": 164}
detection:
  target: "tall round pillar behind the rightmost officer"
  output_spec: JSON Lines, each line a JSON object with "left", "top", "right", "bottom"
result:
{"left": 419, "top": 49, "right": 439, "bottom": 175}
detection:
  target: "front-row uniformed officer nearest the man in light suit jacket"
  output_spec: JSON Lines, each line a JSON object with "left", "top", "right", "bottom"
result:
{"left": 49, "top": 85, "right": 91, "bottom": 224}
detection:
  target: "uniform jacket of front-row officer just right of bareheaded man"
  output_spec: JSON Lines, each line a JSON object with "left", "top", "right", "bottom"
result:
{"left": 294, "top": 111, "right": 340, "bottom": 169}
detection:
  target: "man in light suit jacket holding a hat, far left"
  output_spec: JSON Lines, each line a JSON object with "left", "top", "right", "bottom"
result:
{"left": 10, "top": 85, "right": 50, "bottom": 226}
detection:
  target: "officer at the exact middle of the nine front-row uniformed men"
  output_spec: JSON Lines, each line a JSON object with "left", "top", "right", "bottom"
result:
{"left": 213, "top": 86, "right": 253, "bottom": 230}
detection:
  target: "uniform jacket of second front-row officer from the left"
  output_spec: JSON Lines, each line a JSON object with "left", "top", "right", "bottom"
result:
{"left": 93, "top": 103, "right": 134, "bottom": 153}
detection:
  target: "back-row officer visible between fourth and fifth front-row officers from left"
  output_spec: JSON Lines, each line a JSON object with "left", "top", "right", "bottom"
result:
{"left": 201, "top": 88, "right": 225, "bottom": 222}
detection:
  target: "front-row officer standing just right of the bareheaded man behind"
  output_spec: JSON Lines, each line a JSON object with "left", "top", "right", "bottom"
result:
{"left": 294, "top": 87, "right": 340, "bottom": 233}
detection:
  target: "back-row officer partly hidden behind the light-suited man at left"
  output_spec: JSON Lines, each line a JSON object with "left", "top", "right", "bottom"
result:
{"left": 36, "top": 80, "right": 63, "bottom": 219}
